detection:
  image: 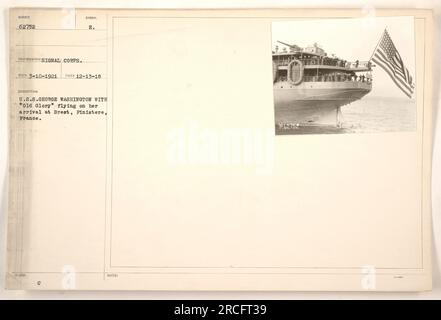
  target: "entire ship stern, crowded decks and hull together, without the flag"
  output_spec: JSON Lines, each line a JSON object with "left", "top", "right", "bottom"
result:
{"left": 273, "top": 42, "right": 372, "bottom": 129}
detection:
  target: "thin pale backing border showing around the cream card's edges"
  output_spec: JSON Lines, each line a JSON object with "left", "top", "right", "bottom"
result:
{"left": 0, "top": 0, "right": 441, "bottom": 299}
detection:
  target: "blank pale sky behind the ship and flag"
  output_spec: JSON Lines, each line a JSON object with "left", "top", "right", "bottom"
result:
{"left": 271, "top": 17, "right": 415, "bottom": 98}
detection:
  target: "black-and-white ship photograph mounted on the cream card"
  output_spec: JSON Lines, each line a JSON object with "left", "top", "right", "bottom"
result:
{"left": 272, "top": 17, "right": 416, "bottom": 135}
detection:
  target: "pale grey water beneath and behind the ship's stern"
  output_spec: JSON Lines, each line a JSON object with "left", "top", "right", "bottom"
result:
{"left": 276, "top": 96, "right": 416, "bottom": 135}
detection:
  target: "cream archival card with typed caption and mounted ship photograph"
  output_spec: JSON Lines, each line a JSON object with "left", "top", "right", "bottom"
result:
{"left": 5, "top": 8, "right": 434, "bottom": 292}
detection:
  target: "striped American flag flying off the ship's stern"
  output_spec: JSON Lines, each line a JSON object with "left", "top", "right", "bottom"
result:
{"left": 372, "top": 30, "right": 415, "bottom": 98}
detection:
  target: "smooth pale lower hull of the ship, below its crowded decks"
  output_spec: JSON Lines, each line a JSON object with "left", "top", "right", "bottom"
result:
{"left": 274, "top": 81, "right": 372, "bottom": 126}
